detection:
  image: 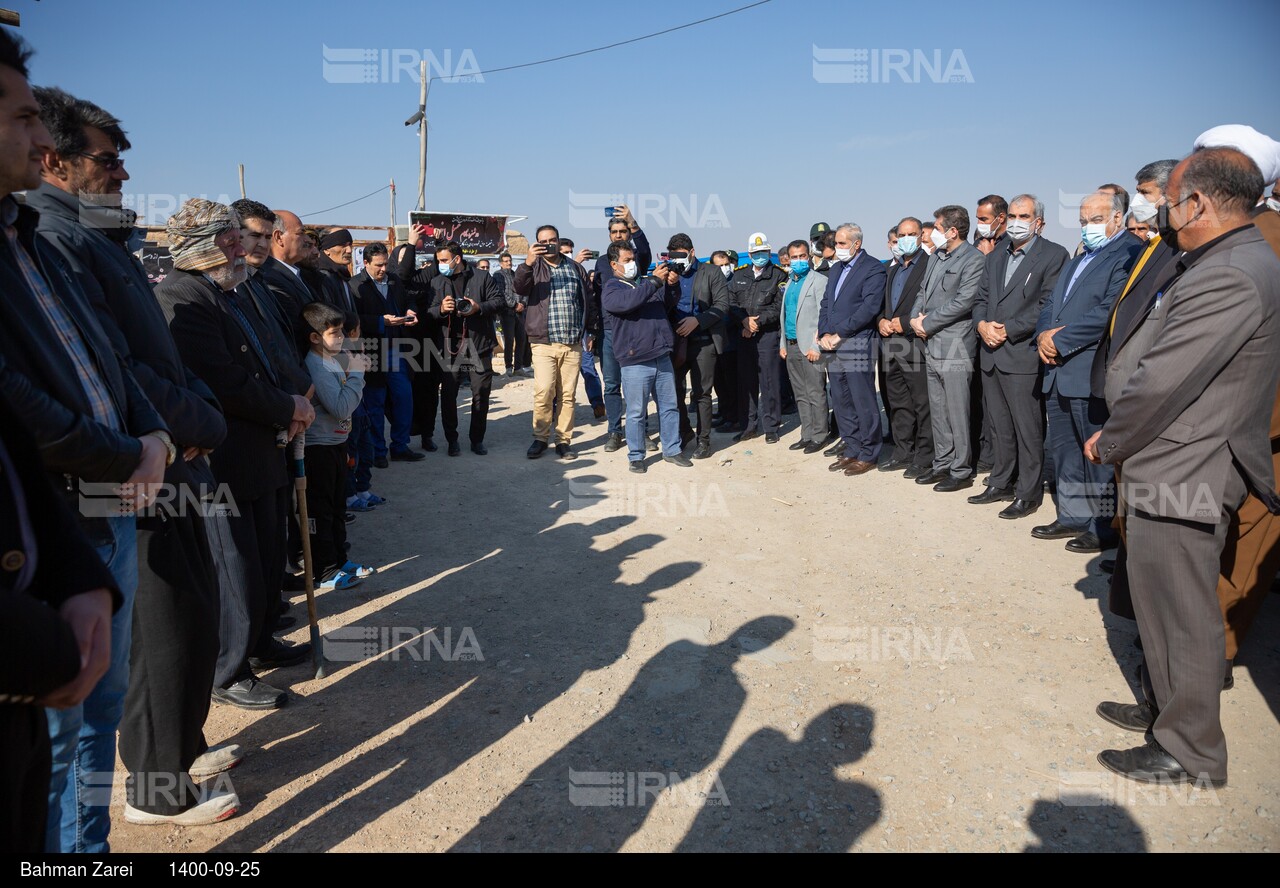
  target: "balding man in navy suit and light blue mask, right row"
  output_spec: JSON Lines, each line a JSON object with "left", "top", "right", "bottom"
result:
{"left": 1032, "top": 192, "right": 1143, "bottom": 551}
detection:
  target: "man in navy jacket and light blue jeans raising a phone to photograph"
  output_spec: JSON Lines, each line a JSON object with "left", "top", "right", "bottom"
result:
{"left": 600, "top": 242, "right": 694, "bottom": 472}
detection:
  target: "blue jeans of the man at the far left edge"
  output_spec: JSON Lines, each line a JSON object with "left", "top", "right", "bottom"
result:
{"left": 45, "top": 516, "right": 138, "bottom": 853}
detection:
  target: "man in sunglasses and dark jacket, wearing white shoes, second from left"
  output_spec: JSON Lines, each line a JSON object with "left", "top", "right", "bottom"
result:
{"left": 27, "top": 88, "right": 236, "bottom": 824}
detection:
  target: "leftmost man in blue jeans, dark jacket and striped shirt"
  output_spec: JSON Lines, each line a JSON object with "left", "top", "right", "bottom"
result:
{"left": 0, "top": 31, "right": 175, "bottom": 853}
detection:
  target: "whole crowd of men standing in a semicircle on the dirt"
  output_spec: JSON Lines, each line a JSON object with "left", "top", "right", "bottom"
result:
{"left": 0, "top": 22, "right": 1280, "bottom": 852}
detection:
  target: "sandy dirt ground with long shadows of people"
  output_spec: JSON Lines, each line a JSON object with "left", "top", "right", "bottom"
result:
{"left": 111, "top": 365, "right": 1280, "bottom": 852}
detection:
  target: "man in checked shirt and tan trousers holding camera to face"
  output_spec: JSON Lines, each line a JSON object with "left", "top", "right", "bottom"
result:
{"left": 516, "top": 225, "right": 600, "bottom": 459}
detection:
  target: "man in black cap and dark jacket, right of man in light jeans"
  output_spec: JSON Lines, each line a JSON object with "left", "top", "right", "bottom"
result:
{"left": 670, "top": 234, "right": 730, "bottom": 459}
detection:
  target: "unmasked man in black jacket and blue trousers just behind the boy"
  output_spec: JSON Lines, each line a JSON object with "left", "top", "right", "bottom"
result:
{"left": 351, "top": 243, "right": 426, "bottom": 468}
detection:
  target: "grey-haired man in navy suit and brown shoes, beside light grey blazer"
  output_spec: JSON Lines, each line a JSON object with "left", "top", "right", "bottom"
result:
{"left": 818, "top": 223, "right": 884, "bottom": 476}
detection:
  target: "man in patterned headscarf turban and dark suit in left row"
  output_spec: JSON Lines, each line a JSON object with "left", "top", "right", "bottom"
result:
{"left": 155, "top": 198, "right": 315, "bottom": 709}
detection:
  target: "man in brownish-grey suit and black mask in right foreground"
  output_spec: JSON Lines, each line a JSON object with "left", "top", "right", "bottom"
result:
{"left": 1084, "top": 148, "right": 1280, "bottom": 786}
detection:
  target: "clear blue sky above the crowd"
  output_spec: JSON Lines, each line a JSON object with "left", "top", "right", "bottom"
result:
{"left": 17, "top": 0, "right": 1280, "bottom": 257}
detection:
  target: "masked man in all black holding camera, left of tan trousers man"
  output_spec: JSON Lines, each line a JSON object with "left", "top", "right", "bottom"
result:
{"left": 429, "top": 241, "right": 507, "bottom": 457}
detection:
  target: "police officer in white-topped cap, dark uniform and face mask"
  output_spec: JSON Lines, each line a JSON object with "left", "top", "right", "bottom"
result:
{"left": 728, "top": 232, "right": 786, "bottom": 444}
